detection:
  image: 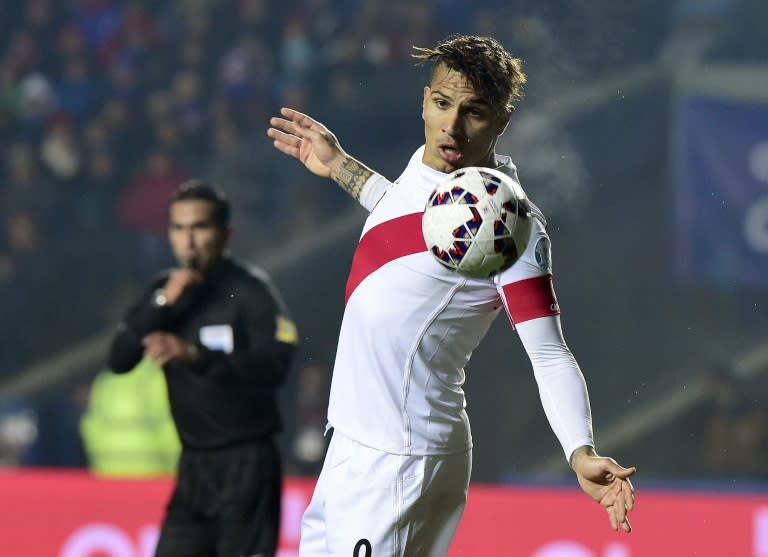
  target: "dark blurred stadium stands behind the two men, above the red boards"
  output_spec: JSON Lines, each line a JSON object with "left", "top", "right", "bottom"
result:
{"left": 0, "top": 0, "right": 768, "bottom": 552}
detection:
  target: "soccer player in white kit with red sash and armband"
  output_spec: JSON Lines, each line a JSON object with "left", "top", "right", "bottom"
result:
{"left": 267, "top": 36, "right": 635, "bottom": 557}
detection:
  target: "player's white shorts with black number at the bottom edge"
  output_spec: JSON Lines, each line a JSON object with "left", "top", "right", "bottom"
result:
{"left": 299, "top": 430, "right": 472, "bottom": 557}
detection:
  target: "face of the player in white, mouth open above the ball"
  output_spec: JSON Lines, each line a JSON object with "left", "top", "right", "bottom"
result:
{"left": 421, "top": 66, "right": 511, "bottom": 173}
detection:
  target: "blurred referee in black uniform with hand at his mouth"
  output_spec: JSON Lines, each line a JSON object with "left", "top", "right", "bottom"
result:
{"left": 108, "top": 180, "right": 297, "bottom": 557}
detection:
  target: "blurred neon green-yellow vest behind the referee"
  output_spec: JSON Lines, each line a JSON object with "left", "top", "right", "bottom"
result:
{"left": 80, "top": 359, "right": 181, "bottom": 477}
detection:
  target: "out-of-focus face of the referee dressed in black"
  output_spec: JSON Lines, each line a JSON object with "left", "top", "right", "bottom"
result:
{"left": 168, "top": 199, "right": 229, "bottom": 272}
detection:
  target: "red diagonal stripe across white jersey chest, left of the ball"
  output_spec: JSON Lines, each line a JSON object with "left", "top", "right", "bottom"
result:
{"left": 344, "top": 213, "right": 427, "bottom": 303}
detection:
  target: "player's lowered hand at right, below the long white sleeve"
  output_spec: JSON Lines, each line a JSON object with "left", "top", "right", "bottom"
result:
{"left": 572, "top": 447, "right": 637, "bottom": 532}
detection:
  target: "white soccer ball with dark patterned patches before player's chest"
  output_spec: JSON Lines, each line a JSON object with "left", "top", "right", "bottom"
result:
{"left": 421, "top": 166, "right": 531, "bottom": 278}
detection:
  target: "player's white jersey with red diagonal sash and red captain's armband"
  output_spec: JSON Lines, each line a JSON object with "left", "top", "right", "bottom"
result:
{"left": 328, "top": 147, "right": 593, "bottom": 457}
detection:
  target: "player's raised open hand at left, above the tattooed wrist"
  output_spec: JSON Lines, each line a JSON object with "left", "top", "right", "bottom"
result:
{"left": 267, "top": 108, "right": 349, "bottom": 178}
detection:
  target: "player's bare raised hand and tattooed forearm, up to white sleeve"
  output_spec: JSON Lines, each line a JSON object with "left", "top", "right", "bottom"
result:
{"left": 267, "top": 108, "right": 373, "bottom": 199}
